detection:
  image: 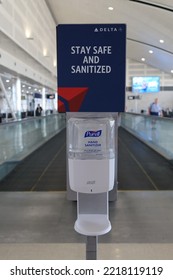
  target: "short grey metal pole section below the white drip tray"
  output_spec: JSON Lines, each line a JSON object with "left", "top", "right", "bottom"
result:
{"left": 86, "top": 236, "right": 98, "bottom": 260}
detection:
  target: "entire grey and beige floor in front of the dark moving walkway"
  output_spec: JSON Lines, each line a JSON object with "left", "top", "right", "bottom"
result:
{"left": 0, "top": 191, "right": 173, "bottom": 260}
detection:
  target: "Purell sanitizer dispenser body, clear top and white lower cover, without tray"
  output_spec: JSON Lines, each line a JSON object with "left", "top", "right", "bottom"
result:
{"left": 67, "top": 118, "right": 115, "bottom": 193}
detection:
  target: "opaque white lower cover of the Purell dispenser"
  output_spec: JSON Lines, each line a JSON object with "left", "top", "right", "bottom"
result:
{"left": 68, "top": 158, "right": 115, "bottom": 193}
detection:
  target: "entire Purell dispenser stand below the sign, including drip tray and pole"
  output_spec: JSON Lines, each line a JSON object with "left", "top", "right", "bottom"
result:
{"left": 67, "top": 113, "right": 117, "bottom": 259}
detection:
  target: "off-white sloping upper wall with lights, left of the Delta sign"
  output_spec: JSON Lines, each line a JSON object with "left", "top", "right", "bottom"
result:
{"left": 0, "top": 0, "right": 56, "bottom": 89}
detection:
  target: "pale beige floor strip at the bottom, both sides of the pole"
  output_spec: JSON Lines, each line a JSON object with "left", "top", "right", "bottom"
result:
{"left": 0, "top": 243, "right": 173, "bottom": 260}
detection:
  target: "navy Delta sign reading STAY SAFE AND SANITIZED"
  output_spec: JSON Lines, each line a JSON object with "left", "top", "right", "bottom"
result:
{"left": 57, "top": 24, "right": 126, "bottom": 112}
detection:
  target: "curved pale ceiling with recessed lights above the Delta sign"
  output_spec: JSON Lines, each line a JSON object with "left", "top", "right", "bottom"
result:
{"left": 45, "top": 0, "right": 173, "bottom": 73}
